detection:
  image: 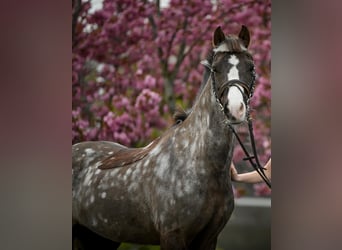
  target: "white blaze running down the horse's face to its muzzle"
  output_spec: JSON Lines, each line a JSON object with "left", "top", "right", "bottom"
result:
{"left": 228, "top": 55, "right": 246, "bottom": 121}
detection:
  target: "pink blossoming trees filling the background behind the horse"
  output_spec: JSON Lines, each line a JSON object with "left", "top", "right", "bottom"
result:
{"left": 72, "top": 0, "right": 271, "bottom": 195}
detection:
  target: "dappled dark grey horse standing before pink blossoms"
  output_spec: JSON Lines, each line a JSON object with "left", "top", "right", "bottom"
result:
{"left": 72, "top": 26, "right": 255, "bottom": 250}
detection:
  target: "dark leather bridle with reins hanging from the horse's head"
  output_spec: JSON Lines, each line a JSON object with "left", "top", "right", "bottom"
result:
{"left": 201, "top": 55, "right": 271, "bottom": 188}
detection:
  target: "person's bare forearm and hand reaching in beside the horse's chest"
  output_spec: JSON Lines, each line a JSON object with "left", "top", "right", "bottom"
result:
{"left": 230, "top": 158, "right": 271, "bottom": 183}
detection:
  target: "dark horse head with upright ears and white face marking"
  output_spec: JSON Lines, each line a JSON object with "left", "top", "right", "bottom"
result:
{"left": 203, "top": 26, "right": 255, "bottom": 123}
